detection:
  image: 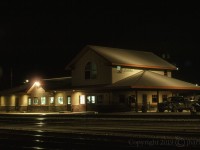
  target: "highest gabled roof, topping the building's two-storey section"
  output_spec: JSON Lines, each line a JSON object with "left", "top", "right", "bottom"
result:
{"left": 66, "top": 45, "right": 177, "bottom": 70}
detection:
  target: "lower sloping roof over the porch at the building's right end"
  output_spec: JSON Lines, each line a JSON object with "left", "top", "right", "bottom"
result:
{"left": 109, "top": 71, "right": 200, "bottom": 90}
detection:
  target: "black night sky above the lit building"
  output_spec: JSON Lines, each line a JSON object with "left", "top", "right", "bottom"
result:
{"left": 0, "top": 0, "right": 200, "bottom": 89}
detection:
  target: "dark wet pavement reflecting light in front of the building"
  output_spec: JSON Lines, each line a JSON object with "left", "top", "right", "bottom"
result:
{"left": 0, "top": 112, "right": 200, "bottom": 150}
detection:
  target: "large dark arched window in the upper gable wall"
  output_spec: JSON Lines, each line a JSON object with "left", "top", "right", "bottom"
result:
{"left": 85, "top": 62, "right": 97, "bottom": 79}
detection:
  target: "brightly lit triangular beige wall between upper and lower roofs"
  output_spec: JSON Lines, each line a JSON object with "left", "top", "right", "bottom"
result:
{"left": 112, "top": 67, "right": 142, "bottom": 83}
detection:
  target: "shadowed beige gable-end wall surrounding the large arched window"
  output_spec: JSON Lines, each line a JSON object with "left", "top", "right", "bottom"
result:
{"left": 72, "top": 50, "right": 111, "bottom": 86}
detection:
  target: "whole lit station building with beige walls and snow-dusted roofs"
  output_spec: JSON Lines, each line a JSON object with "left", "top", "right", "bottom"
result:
{"left": 0, "top": 45, "right": 200, "bottom": 112}
